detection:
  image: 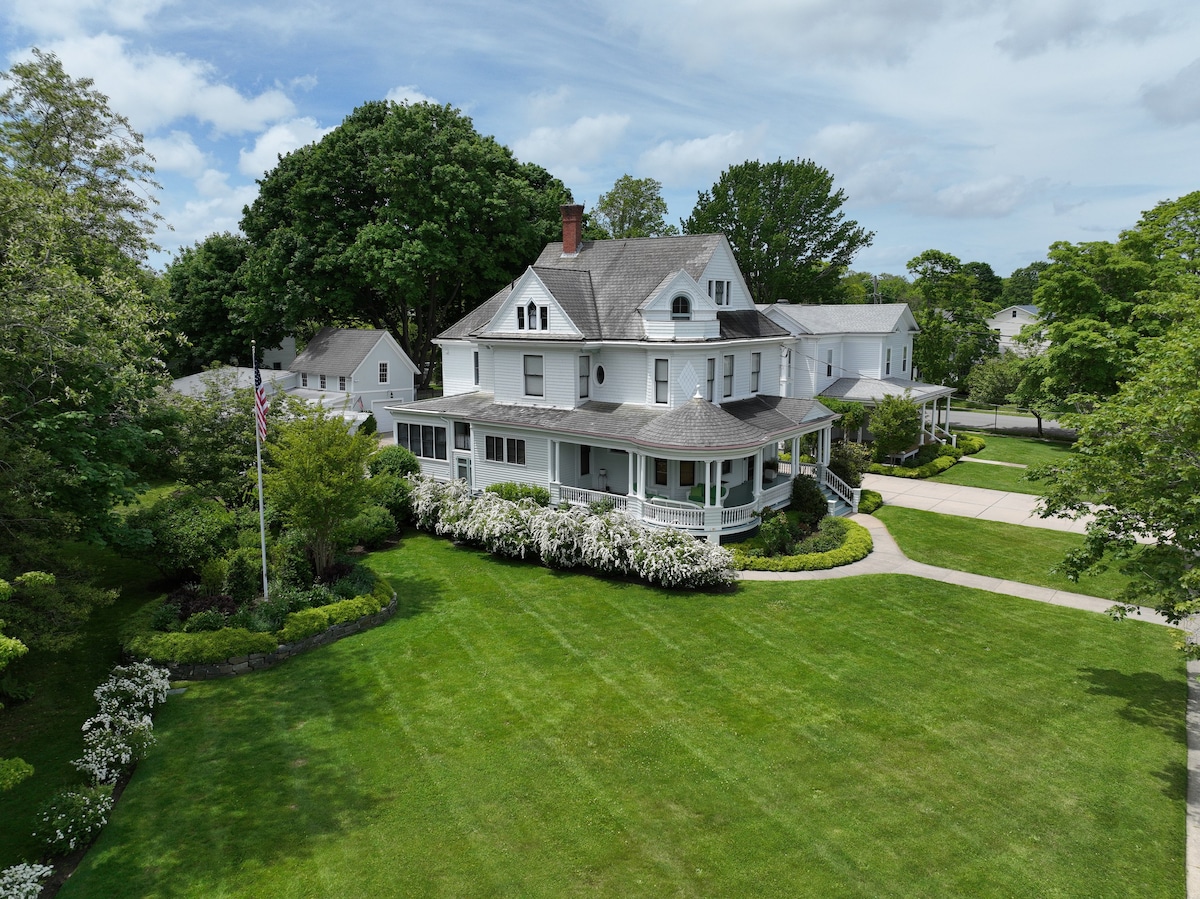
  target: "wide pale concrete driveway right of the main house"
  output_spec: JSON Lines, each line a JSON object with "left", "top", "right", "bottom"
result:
{"left": 863, "top": 474, "right": 1088, "bottom": 534}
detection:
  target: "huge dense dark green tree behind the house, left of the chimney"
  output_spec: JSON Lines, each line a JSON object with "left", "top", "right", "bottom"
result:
{"left": 241, "top": 101, "right": 570, "bottom": 380}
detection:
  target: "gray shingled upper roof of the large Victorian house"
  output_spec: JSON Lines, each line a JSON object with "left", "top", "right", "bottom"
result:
{"left": 438, "top": 234, "right": 786, "bottom": 341}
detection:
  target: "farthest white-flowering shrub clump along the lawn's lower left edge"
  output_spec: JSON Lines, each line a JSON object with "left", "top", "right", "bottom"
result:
{"left": 72, "top": 663, "right": 170, "bottom": 784}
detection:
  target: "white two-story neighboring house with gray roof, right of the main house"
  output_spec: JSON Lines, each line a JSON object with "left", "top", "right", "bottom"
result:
{"left": 760, "top": 302, "right": 954, "bottom": 443}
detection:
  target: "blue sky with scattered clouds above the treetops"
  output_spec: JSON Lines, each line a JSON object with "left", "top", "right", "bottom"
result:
{"left": 0, "top": 0, "right": 1200, "bottom": 275}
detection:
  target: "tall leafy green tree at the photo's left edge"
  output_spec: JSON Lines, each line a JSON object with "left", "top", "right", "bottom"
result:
{"left": 0, "top": 53, "right": 164, "bottom": 542}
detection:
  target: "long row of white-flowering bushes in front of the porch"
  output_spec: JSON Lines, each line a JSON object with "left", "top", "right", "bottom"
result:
{"left": 413, "top": 478, "right": 734, "bottom": 588}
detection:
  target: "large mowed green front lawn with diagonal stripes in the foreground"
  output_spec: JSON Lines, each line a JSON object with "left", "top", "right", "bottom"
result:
{"left": 60, "top": 535, "right": 1186, "bottom": 899}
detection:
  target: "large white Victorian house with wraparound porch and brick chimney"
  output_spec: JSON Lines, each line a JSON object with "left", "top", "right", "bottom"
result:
{"left": 391, "top": 206, "right": 945, "bottom": 540}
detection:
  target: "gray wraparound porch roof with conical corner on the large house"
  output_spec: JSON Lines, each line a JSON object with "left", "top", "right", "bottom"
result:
{"left": 388, "top": 392, "right": 836, "bottom": 453}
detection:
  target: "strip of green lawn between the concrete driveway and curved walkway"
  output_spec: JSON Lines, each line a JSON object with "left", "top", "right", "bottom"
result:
{"left": 875, "top": 505, "right": 1128, "bottom": 600}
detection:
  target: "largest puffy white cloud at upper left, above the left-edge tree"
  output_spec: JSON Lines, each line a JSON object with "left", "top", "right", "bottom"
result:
{"left": 47, "top": 34, "right": 295, "bottom": 133}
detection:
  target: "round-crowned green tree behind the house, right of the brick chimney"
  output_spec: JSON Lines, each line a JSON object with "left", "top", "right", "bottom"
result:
{"left": 683, "top": 160, "right": 875, "bottom": 302}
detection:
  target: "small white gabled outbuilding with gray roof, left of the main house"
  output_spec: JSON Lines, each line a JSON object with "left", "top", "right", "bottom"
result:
{"left": 173, "top": 328, "right": 416, "bottom": 432}
